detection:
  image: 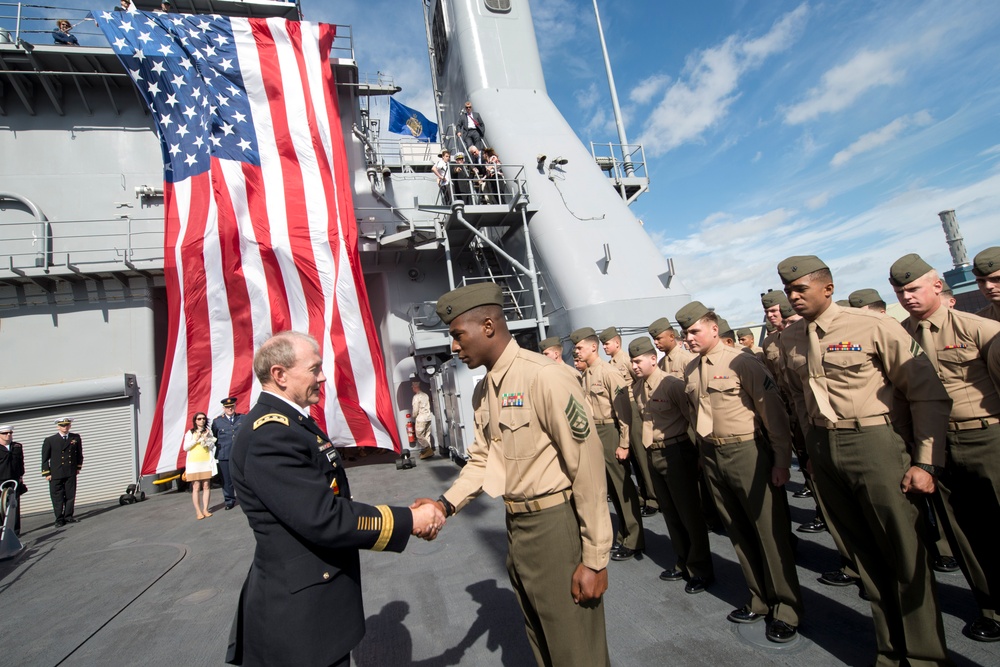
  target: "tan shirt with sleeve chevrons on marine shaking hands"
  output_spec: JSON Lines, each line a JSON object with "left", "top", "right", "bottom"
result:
{"left": 444, "top": 340, "right": 613, "bottom": 570}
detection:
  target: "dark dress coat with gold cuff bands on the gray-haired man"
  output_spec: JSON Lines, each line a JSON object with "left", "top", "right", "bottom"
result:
{"left": 226, "top": 393, "right": 413, "bottom": 666}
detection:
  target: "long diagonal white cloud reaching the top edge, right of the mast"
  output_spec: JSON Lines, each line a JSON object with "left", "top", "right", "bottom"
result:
{"left": 639, "top": 4, "right": 808, "bottom": 157}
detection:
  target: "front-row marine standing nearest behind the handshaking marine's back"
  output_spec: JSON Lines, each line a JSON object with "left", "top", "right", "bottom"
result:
{"left": 569, "top": 327, "right": 646, "bottom": 560}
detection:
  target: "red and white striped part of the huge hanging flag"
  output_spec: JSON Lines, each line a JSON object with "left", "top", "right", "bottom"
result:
{"left": 142, "top": 18, "right": 400, "bottom": 475}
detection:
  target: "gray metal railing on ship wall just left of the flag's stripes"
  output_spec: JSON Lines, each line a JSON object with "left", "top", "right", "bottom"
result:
{"left": 0, "top": 216, "right": 164, "bottom": 277}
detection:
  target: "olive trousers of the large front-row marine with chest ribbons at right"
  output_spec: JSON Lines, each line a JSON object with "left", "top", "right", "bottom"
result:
{"left": 806, "top": 425, "right": 951, "bottom": 667}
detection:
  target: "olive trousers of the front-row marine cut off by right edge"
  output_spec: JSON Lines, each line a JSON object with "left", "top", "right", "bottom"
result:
{"left": 938, "top": 424, "right": 1000, "bottom": 620}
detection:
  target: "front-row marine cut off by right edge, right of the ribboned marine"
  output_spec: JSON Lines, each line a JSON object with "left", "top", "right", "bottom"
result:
{"left": 889, "top": 255, "right": 1000, "bottom": 641}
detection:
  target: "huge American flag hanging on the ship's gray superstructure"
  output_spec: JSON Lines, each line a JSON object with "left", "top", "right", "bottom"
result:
{"left": 93, "top": 6, "right": 400, "bottom": 475}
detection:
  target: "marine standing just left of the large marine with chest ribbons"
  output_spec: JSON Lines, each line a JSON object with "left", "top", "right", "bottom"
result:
{"left": 676, "top": 301, "right": 802, "bottom": 643}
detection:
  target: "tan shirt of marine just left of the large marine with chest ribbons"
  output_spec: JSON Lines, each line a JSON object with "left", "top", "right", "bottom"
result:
{"left": 684, "top": 341, "right": 792, "bottom": 468}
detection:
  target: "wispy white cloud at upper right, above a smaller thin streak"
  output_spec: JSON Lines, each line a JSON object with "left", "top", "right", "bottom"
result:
{"left": 785, "top": 48, "right": 905, "bottom": 125}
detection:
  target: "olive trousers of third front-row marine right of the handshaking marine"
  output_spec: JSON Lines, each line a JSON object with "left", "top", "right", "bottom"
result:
{"left": 646, "top": 439, "right": 715, "bottom": 578}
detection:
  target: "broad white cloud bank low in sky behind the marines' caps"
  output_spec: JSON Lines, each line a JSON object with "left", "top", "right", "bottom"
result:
{"left": 656, "top": 174, "right": 1000, "bottom": 326}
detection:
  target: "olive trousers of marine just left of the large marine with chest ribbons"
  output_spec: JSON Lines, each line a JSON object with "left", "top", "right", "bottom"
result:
{"left": 701, "top": 438, "right": 802, "bottom": 627}
